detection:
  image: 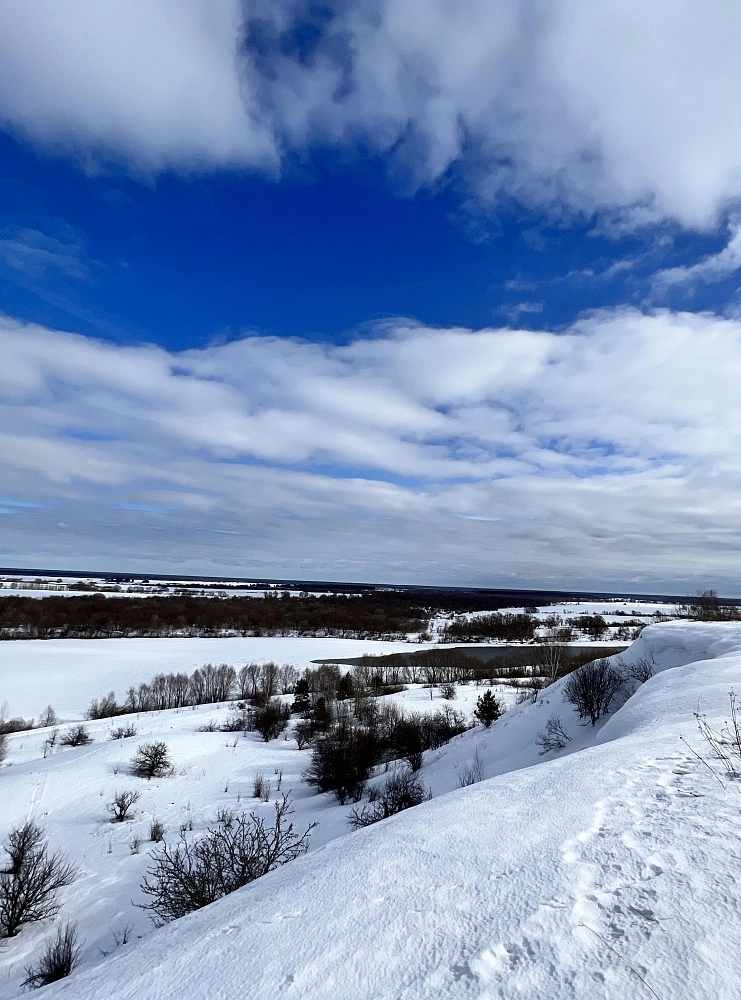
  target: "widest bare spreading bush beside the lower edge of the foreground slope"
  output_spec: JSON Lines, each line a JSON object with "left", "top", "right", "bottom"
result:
{"left": 142, "top": 795, "right": 315, "bottom": 927}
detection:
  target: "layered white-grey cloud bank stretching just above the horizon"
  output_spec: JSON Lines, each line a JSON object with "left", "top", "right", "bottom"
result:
{"left": 0, "top": 309, "right": 741, "bottom": 592}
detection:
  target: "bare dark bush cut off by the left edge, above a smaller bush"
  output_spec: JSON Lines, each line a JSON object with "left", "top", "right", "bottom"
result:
{"left": 0, "top": 821, "right": 77, "bottom": 937}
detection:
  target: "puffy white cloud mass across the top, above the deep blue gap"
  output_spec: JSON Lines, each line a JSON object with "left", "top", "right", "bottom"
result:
{"left": 0, "top": 0, "right": 741, "bottom": 228}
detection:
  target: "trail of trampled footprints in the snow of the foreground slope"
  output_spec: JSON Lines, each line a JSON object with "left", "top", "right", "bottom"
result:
{"left": 470, "top": 755, "right": 702, "bottom": 998}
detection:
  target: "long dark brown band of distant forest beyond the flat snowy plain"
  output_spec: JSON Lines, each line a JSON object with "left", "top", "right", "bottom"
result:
{"left": 0, "top": 590, "right": 548, "bottom": 639}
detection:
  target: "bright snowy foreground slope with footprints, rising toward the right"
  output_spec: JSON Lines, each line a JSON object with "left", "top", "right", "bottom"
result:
{"left": 1, "top": 622, "right": 741, "bottom": 1000}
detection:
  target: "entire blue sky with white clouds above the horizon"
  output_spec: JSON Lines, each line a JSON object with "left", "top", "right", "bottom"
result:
{"left": 0, "top": 0, "right": 741, "bottom": 595}
